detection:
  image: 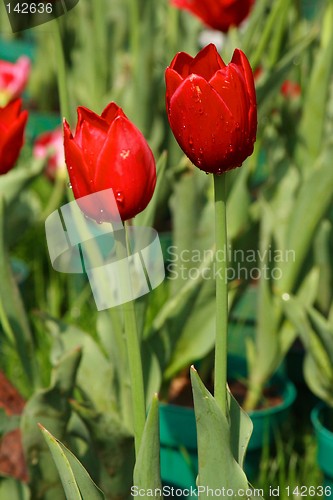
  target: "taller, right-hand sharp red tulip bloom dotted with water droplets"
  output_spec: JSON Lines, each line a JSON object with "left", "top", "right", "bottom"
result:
{"left": 165, "top": 44, "right": 257, "bottom": 174}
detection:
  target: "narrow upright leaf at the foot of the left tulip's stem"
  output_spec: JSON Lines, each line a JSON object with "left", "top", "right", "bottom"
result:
{"left": 133, "top": 396, "right": 163, "bottom": 500}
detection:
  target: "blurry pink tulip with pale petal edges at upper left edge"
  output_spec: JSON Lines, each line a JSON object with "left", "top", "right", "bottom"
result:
{"left": 0, "top": 56, "right": 30, "bottom": 106}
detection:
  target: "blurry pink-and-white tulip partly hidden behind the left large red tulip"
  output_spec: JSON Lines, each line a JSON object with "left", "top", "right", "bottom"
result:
{"left": 33, "top": 128, "right": 66, "bottom": 180}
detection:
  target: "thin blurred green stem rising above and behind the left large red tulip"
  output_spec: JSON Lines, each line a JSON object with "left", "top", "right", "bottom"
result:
{"left": 52, "top": 19, "right": 70, "bottom": 120}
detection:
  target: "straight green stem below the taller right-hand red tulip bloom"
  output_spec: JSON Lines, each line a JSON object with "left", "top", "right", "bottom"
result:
{"left": 214, "top": 174, "right": 228, "bottom": 416}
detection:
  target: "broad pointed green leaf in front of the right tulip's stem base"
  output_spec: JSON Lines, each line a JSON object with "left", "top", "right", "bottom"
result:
{"left": 191, "top": 369, "right": 248, "bottom": 499}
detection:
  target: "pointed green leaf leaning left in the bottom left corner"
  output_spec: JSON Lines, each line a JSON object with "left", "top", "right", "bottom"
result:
{"left": 39, "top": 425, "right": 105, "bottom": 500}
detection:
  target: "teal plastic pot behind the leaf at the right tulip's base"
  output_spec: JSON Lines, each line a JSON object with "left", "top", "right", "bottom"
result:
{"left": 160, "top": 376, "right": 296, "bottom": 489}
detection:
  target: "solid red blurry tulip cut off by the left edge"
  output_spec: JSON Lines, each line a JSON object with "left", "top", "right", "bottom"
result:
{"left": 0, "top": 99, "right": 28, "bottom": 174}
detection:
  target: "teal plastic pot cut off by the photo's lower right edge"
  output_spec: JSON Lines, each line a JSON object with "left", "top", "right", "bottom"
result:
{"left": 311, "top": 403, "right": 333, "bottom": 498}
